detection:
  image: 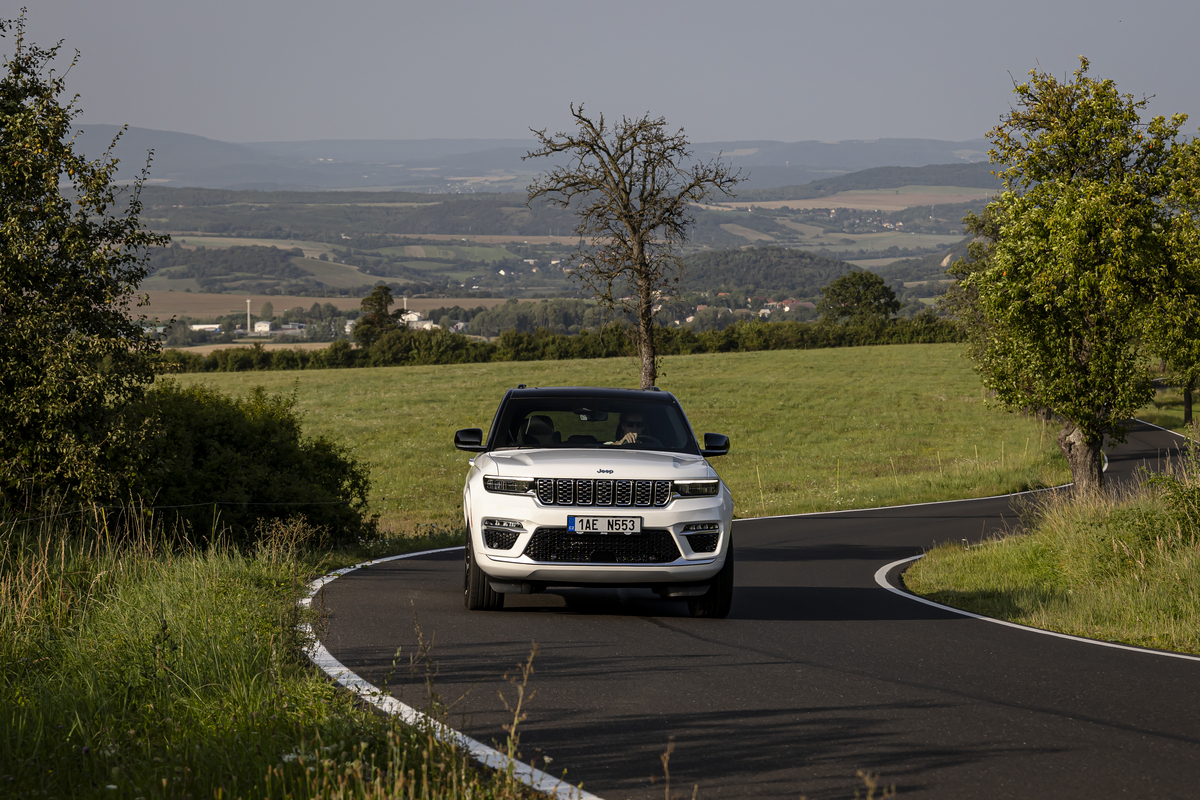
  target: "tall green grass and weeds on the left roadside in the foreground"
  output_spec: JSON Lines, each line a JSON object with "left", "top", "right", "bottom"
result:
{"left": 0, "top": 511, "right": 540, "bottom": 799}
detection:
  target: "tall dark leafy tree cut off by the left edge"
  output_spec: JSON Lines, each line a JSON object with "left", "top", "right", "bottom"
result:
{"left": 0, "top": 19, "right": 168, "bottom": 507}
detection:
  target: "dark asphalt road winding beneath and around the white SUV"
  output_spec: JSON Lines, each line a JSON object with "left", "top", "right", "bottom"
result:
{"left": 323, "top": 426, "right": 1200, "bottom": 800}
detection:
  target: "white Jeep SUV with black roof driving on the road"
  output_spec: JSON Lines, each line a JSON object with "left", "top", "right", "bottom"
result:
{"left": 454, "top": 385, "right": 733, "bottom": 618}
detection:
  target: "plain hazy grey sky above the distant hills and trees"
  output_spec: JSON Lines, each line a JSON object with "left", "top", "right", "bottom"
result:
{"left": 16, "top": 0, "right": 1200, "bottom": 142}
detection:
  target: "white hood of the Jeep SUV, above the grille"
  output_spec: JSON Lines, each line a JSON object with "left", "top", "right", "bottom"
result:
{"left": 476, "top": 447, "right": 716, "bottom": 481}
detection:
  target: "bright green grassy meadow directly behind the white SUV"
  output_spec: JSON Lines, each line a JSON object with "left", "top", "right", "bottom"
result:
{"left": 166, "top": 344, "right": 1068, "bottom": 530}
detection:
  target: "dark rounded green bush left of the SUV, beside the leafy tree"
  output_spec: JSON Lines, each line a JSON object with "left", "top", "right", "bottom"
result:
{"left": 133, "top": 381, "right": 376, "bottom": 546}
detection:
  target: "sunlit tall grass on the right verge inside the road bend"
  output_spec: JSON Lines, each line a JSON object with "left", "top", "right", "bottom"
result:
{"left": 904, "top": 452, "right": 1200, "bottom": 652}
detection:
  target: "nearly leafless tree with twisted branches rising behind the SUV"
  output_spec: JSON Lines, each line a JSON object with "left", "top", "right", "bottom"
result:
{"left": 524, "top": 103, "right": 742, "bottom": 389}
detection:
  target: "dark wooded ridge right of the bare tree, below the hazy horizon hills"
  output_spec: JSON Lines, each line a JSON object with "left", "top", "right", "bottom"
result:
{"left": 738, "top": 162, "right": 1001, "bottom": 201}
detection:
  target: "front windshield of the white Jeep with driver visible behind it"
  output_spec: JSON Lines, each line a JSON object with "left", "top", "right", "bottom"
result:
{"left": 492, "top": 397, "right": 698, "bottom": 453}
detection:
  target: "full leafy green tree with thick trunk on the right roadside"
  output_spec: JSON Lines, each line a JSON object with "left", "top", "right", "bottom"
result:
{"left": 958, "top": 59, "right": 1189, "bottom": 489}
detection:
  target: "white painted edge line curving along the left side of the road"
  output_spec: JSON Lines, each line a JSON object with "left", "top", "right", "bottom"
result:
{"left": 296, "top": 545, "right": 602, "bottom": 800}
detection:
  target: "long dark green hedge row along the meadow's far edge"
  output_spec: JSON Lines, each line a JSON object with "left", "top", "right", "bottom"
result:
{"left": 162, "top": 313, "right": 962, "bottom": 372}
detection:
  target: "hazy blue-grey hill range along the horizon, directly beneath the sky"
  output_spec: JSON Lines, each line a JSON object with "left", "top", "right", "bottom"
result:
{"left": 77, "top": 124, "right": 988, "bottom": 193}
